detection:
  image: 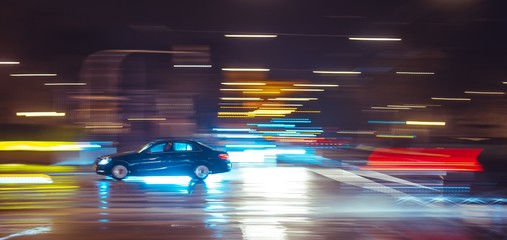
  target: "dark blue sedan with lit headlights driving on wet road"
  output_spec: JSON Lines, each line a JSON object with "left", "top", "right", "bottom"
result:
{"left": 95, "top": 139, "right": 232, "bottom": 180}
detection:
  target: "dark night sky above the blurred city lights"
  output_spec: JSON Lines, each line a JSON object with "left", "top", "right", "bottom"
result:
{"left": 0, "top": 0, "right": 507, "bottom": 133}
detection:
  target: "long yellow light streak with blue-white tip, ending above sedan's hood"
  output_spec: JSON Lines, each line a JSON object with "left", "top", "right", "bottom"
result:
{"left": 0, "top": 141, "right": 101, "bottom": 151}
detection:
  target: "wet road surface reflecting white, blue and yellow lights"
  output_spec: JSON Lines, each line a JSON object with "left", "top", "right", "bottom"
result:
{"left": 0, "top": 167, "right": 507, "bottom": 240}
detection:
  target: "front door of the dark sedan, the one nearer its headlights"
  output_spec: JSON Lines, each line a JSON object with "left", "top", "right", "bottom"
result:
{"left": 133, "top": 142, "right": 169, "bottom": 175}
